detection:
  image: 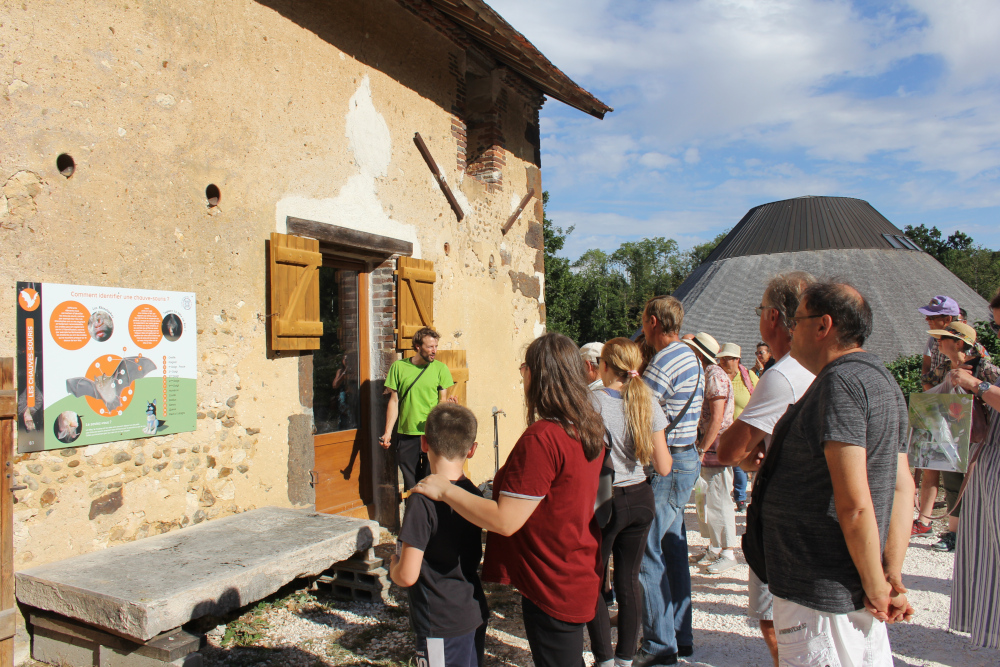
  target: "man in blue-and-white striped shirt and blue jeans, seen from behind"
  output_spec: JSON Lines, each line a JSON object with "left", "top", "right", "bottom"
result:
{"left": 635, "top": 296, "right": 704, "bottom": 667}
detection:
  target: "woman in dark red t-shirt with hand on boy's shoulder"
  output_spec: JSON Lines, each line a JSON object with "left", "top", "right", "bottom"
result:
{"left": 413, "top": 333, "right": 604, "bottom": 667}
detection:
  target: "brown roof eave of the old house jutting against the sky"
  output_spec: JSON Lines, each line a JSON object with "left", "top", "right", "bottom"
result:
{"left": 429, "top": 0, "right": 614, "bottom": 119}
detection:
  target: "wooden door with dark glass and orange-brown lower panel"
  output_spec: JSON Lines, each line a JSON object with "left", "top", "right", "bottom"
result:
{"left": 313, "top": 260, "right": 371, "bottom": 519}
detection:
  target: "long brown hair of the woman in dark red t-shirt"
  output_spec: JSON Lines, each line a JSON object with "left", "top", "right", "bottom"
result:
{"left": 524, "top": 333, "right": 604, "bottom": 461}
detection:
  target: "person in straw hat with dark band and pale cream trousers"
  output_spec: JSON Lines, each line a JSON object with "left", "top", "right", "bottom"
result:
{"left": 684, "top": 332, "right": 738, "bottom": 574}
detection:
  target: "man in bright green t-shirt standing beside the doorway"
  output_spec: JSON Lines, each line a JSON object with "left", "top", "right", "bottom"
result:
{"left": 379, "top": 327, "right": 458, "bottom": 491}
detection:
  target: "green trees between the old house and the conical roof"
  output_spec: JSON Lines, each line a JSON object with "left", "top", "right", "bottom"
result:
{"left": 542, "top": 192, "right": 727, "bottom": 344}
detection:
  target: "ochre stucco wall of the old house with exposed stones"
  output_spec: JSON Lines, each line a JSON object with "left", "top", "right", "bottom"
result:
{"left": 0, "top": 0, "right": 544, "bottom": 580}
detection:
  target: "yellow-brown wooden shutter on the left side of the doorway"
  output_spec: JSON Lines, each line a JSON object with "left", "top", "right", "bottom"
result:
{"left": 268, "top": 233, "right": 323, "bottom": 350}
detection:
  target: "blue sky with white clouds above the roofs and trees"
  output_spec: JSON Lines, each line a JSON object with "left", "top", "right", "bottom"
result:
{"left": 488, "top": 0, "right": 1000, "bottom": 258}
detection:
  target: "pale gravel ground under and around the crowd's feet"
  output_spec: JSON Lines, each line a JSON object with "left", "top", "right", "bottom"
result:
{"left": 23, "top": 505, "right": 1000, "bottom": 667}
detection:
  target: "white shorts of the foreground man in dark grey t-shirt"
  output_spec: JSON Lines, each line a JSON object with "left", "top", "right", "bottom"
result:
{"left": 774, "top": 597, "right": 892, "bottom": 667}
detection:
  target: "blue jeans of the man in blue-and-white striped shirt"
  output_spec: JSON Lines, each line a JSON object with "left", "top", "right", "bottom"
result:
{"left": 639, "top": 447, "right": 701, "bottom": 655}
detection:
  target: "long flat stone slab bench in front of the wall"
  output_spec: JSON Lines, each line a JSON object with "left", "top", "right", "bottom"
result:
{"left": 15, "top": 507, "right": 379, "bottom": 642}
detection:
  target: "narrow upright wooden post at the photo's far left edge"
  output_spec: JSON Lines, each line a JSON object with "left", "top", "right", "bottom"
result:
{"left": 0, "top": 357, "right": 17, "bottom": 667}
